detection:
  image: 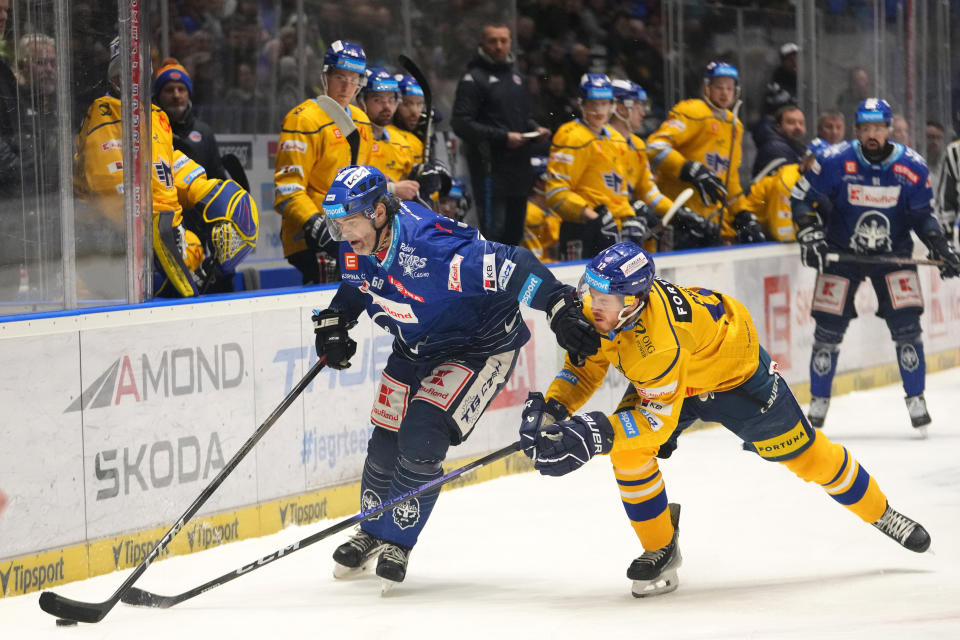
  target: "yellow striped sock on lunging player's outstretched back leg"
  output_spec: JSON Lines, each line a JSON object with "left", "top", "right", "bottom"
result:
{"left": 781, "top": 432, "right": 887, "bottom": 524}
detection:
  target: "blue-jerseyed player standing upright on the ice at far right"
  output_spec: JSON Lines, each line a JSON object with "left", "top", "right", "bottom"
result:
{"left": 790, "top": 98, "right": 960, "bottom": 429}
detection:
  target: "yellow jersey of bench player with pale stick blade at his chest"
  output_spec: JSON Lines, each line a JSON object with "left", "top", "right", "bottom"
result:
{"left": 273, "top": 98, "right": 373, "bottom": 256}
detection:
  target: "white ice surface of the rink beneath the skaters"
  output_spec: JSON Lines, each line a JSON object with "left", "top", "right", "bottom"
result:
{"left": 0, "top": 369, "right": 960, "bottom": 640}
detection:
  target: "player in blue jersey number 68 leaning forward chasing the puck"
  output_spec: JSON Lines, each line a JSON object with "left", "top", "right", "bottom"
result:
{"left": 313, "top": 166, "right": 600, "bottom": 589}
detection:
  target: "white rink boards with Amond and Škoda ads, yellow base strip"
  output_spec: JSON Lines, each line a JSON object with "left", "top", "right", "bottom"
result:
{"left": 0, "top": 245, "right": 960, "bottom": 596}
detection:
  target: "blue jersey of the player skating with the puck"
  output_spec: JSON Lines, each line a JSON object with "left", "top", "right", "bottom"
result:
{"left": 330, "top": 202, "right": 572, "bottom": 360}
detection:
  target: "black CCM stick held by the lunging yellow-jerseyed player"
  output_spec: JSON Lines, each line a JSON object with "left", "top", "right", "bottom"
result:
{"left": 123, "top": 441, "right": 523, "bottom": 609}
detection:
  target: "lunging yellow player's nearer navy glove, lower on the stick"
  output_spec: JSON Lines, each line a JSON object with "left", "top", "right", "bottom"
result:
{"left": 533, "top": 411, "right": 613, "bottom": 476}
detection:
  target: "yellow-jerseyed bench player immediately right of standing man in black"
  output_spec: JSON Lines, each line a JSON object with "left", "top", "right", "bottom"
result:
{"left": 547, "top": 73, "right": 634, "bottom": 259}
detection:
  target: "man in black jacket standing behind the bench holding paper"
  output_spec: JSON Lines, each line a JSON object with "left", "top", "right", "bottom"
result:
{"left": 451, "top": 24, "right": 550, "bottom": 245}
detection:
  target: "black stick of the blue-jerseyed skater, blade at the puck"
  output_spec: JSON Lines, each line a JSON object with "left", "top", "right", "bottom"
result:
{"left": 40, "top": 358, "right": 327, "bottom": 622}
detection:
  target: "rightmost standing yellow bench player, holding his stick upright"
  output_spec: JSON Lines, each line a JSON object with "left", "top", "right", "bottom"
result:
{"left": 647, "top": 62, "right": 743, "bottom": 248}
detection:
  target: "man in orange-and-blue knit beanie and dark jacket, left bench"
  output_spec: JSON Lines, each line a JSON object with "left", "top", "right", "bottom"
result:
{"left": 153, "top": 58, "right": 227, "bottom": 179}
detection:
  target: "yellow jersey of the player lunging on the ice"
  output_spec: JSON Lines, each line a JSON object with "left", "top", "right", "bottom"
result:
{"left": 547, "top": 279, "right": 760, "bottom": 456}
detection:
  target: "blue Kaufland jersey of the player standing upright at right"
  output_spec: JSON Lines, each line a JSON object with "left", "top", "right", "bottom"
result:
{"left": 790, "top": 140, "right": 937, "bottom": 255}
